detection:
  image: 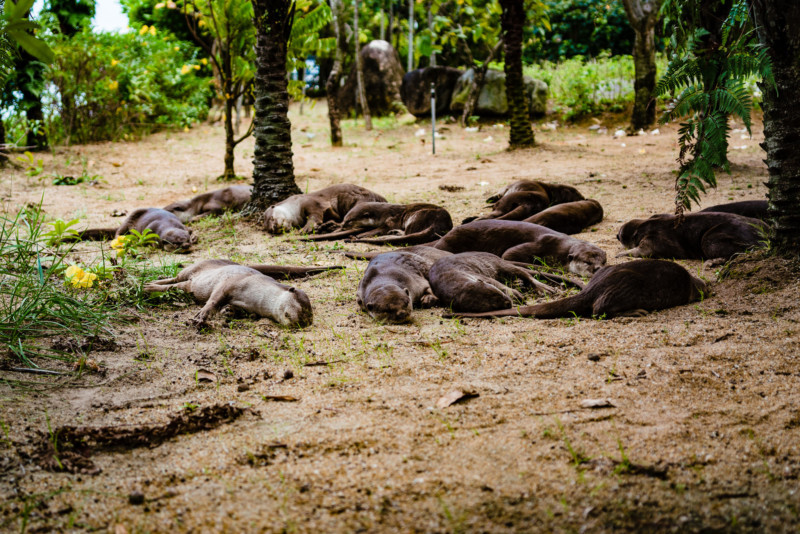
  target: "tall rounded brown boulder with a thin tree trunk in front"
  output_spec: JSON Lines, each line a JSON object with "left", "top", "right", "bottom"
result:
{"left": 339, "top": 40, "right": 405, "bottom": 115}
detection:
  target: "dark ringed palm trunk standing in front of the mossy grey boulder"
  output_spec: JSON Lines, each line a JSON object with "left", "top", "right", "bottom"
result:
{"left": 500, "top": 0, "right": 534, "bottom": 148}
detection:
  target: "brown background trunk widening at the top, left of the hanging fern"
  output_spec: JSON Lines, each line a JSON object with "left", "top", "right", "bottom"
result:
{"left": 622, "top": 0, "right": 664, "bottom": 131}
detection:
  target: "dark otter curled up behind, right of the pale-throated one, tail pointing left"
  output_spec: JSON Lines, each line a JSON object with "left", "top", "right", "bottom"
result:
{"left": 305, "top": 202, "right": 453, "bottom": 246}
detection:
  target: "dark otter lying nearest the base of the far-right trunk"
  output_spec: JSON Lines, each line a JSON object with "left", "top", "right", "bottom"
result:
{"left": 617, "top": 212, "right": 769, "bottom": 260}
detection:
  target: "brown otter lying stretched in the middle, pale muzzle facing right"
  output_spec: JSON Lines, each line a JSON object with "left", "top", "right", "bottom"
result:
{"left": 434, "top": 219, "right": 606, "bottom": 276}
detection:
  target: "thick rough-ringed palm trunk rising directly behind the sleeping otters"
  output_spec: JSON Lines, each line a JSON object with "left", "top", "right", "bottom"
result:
{"left": 246, "top": 0, "right": 300, "bottom": 214}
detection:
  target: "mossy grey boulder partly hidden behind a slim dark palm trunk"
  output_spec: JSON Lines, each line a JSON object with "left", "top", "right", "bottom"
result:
{"left": 450, "top": 69, "right": 547, "bottom": 117}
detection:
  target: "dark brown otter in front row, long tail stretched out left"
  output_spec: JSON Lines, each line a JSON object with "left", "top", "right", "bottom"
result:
{"left": 446, "top": 260, "right": 708, "bottom": 319}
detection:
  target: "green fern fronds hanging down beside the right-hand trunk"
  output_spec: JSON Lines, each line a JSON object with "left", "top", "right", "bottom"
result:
{"left": 656, "top": 0, "right": 772, "bottom": 215}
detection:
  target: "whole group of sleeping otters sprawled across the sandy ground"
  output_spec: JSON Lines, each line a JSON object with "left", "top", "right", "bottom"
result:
{"left": 78, "top": 180, "right": 768, "bottom": 327}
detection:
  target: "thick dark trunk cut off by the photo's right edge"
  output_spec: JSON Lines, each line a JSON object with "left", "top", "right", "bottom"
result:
{"left": 750, "top": 0, "right": 800, "bottom": 256}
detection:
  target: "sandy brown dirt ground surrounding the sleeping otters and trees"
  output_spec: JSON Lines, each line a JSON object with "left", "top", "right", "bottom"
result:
{"left": 0, "top": 102, "right": 800, "bottom": 534}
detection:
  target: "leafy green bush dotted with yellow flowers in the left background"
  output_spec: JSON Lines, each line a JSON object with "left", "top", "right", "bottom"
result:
{"left": 45, "top": 27, "right": 210, "bottom": 143}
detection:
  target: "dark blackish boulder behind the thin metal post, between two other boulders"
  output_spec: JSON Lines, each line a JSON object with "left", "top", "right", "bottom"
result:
{"left": 400, "top": 67, "right": 464, "bottom": 116}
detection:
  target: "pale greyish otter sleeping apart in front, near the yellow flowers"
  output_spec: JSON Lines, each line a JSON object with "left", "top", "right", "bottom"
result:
{"left": 143, "top": 260, "right": 340, "bottom": 327}
